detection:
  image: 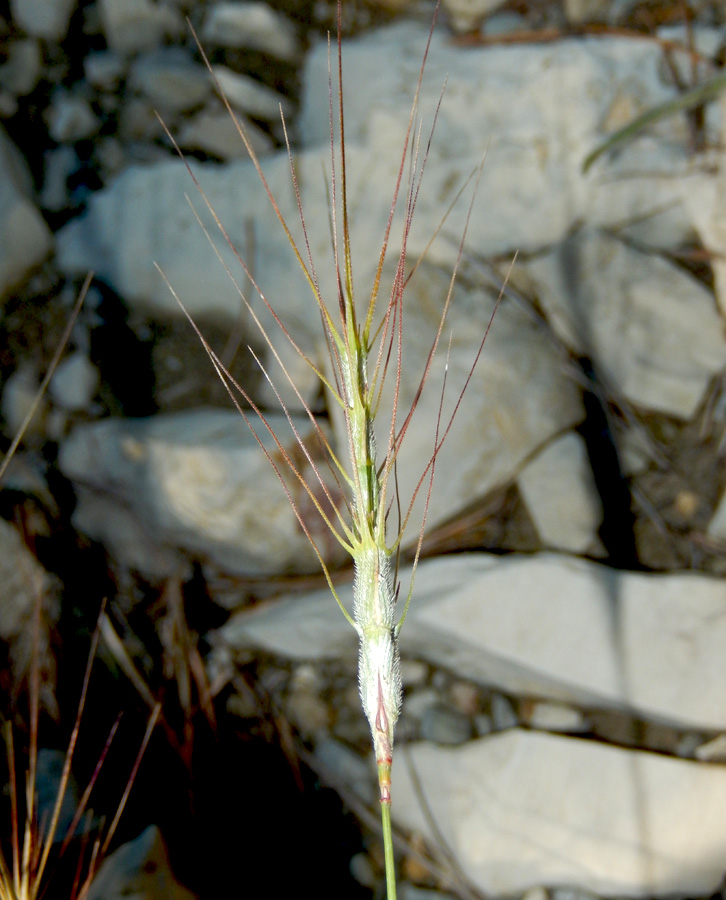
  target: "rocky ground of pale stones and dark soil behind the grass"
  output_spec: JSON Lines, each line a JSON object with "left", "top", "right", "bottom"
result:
{"left": 0, "top": 0, "right": 726, "bottom": 900}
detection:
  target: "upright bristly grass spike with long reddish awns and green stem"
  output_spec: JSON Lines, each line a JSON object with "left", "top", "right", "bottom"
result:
{"left": 160, "top": 2, "right": 510, "bottom": 900}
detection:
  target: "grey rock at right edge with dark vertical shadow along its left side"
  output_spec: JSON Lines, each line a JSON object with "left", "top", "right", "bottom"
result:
{"left": 526, "top": 230, "right": 726, "bottom": 419}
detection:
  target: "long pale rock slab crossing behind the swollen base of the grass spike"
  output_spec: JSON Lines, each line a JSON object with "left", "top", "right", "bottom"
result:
{"left": 221, "top": 554, "right": 726, "bottom": 730}
